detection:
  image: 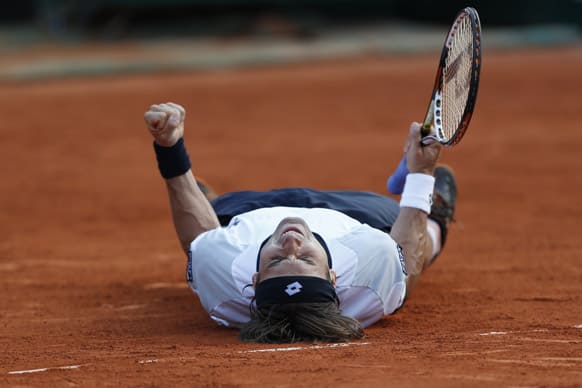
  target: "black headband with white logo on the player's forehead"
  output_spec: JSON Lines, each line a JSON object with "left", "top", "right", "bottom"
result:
{"left": 255, "top": 276, "right": 339, "bottom": 307}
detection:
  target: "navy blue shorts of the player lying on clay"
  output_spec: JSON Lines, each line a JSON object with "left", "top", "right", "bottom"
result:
{"left": 211, "top": 187, "right": 400, "bottom": 233}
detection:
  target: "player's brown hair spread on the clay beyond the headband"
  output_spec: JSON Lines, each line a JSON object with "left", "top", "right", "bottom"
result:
{"left": 239, "top": 302, "right": 364, "bottom": 343}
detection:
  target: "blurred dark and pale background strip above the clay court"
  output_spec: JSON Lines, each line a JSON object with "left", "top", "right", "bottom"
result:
{"left": 0, "top": 0, "right": 582, "bottom": 81}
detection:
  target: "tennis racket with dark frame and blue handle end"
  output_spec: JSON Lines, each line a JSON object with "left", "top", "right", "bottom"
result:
{"left": 387, "top": 7, "right": 481, "bottom": 194}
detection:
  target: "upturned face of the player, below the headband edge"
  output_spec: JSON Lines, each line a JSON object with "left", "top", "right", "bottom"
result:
{"left": 258, "top": 217, "right": 335, "bottom": 283}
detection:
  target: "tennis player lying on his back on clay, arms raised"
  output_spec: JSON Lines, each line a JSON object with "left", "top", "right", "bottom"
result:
{"left": 145, "top": 103, "right": 456, "bottom": 343}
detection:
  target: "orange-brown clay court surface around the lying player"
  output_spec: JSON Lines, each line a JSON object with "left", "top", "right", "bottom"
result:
{"left": 0, "top": 46, "right": 582, "bottom": 387}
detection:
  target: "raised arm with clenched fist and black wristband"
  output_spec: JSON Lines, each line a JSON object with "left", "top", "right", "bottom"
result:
{"left": 144, "top": 102, "right": 220, "bottom": 252}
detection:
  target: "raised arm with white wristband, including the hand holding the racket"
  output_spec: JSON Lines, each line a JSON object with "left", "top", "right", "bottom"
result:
{"left": 390, "top": 123, "right": 442, "bottom": 291}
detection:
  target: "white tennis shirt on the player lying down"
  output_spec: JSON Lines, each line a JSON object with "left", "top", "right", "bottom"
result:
{"left": 186, "top": 207, "right": 406, "bottom": 327}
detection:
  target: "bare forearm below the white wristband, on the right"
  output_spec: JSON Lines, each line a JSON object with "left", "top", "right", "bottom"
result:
{"left": 390, "top": 207, "right": 432, "bottom": 290}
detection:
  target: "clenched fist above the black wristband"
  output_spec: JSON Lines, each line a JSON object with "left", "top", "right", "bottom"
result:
{"left": 144, "top": 102, "right": 186, "bottom": 147}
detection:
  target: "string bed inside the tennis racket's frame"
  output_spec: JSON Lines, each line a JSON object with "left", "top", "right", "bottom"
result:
{"left": 442, "top": 15, "right": 473, "bottom": 140}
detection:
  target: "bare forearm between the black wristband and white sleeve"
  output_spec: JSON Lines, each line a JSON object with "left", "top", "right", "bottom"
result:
{"left": 166, "top": 170, "right": 220, "bottom": 252}
